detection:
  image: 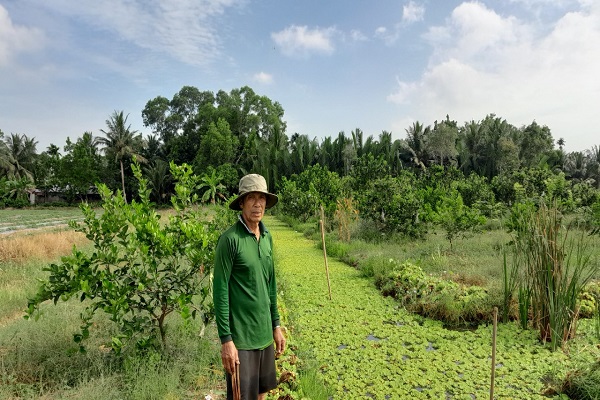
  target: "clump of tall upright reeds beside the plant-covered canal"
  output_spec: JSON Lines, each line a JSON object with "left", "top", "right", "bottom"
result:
{"left": 513, "top": 205, "right": 598, "bottom": 349}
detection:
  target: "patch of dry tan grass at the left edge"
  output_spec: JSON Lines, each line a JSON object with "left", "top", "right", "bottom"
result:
{"left": 0, "top": 230, "right": 89, "bottom": 264}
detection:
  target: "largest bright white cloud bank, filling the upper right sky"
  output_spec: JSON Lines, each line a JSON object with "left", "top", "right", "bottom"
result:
{"left": 388, "top": 3, "right": 600, "bottom": 148}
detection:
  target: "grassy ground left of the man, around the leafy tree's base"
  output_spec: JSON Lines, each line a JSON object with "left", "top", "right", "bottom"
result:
{"left": 0, "top": 225, "right": 224, "bottom": 400}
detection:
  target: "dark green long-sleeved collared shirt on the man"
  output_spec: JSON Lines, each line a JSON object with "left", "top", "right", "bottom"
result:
{"left": 213, "top": 217, "right": 279, "bottom": 350}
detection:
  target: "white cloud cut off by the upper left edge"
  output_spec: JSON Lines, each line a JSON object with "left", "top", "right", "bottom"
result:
{"left": 0, "top": 4, "right": 44, "bottom": 67}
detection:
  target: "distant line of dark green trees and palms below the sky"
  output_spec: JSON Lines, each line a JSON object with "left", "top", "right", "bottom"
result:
{"left": 0, "top": 86, "right": 600, "bottom": 211}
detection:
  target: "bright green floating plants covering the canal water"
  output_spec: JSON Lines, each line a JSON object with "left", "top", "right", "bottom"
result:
{"left": 267, "top": 219, "right": 600, "bottom": 399}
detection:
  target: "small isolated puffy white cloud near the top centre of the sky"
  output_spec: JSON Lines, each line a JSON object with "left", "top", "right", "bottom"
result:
{"left": 271, "top": 25, "right": 337, "bottom": 57}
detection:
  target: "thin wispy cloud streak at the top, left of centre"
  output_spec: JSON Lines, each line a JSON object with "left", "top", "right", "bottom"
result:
{"left": 35, "top": 0, "right": 241, "bottom": 65}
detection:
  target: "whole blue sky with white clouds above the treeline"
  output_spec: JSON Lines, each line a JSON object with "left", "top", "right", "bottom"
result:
{"left": 0, "top": 0, "right": 600, "bottom": 152}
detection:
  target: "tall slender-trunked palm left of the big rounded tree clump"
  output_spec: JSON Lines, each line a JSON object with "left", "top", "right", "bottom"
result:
{"left": 98, "top": 110, "right": 146, "bottom": 202}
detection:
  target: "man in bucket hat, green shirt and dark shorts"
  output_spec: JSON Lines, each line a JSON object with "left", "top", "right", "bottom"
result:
{"left": 213, "top": 174, "right": 285, "bottom": 400}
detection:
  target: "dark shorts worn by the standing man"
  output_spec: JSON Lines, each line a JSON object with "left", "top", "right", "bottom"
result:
{"left": 226, "top": 344, "right": 277, "bottom": 400}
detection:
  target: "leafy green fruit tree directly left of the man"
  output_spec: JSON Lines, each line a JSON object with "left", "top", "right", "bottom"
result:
{"left": 28, "top": 163, "right": 219, "bottom": 351}
